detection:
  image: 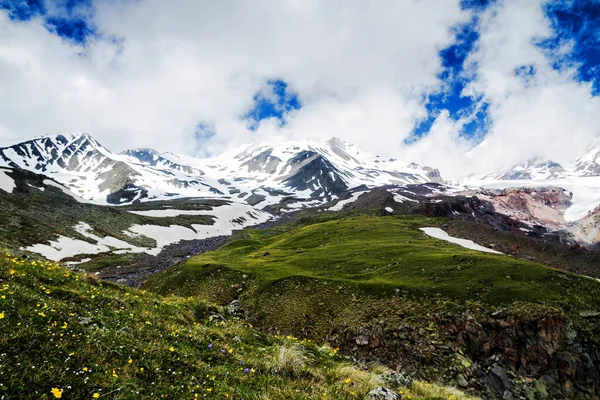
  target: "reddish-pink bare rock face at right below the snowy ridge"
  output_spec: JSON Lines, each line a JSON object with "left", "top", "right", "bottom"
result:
{"left": 476, "top": 187, "right": 572, "bottom": 230}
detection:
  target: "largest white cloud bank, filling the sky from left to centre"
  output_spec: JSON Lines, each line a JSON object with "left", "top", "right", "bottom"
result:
{"left": 0, "top": 0, "right": 468, "bottom": 153}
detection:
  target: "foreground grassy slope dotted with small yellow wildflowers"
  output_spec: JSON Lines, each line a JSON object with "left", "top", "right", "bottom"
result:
{"left": 0, "top": 251, "right": 476, "bottom": 399}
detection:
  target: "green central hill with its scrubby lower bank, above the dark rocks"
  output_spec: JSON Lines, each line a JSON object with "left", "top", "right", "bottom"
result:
{"left": 146, "top": 215, "right": 600, "bottom": 339}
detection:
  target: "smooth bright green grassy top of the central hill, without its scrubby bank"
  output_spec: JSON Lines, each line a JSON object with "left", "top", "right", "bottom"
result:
{"left": 146, "top": 215, "right": 600, "bottom": 324}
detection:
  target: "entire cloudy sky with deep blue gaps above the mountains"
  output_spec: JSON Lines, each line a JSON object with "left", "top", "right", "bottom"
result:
{"left": 0, "top": 0, "right": 600, "bottom": 177}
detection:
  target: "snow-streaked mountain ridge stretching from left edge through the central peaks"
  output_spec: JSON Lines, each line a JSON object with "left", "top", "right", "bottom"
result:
{"left": 0, "top": 134, "right": 442, "bottom": 208}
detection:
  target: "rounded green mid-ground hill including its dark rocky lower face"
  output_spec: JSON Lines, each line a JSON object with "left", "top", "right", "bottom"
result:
{"left": 146, "top": 214, "right": 600, "bottom": 397}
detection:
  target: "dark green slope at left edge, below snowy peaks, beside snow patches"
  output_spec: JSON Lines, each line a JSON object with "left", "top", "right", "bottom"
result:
{"left": 0, "top": 170, "right": 225, "bottom": 253}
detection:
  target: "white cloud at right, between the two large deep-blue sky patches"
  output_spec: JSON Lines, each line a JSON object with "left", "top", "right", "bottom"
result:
{"left": 442, "top": 0, "right": 600, "bottom": 177}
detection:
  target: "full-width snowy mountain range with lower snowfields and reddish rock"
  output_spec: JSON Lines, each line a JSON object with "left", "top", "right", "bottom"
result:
{"left": 0, "top": 134, "right": 600, "bottom": 260}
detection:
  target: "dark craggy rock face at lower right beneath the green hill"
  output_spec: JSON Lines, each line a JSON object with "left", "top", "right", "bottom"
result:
{"left": 328, "top": 314, "right": 600, "bottom": 399}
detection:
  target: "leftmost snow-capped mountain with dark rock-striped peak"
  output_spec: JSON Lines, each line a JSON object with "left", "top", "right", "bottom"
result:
{"left": 0, "top": 134, "right": 220, "bottom": 204}
